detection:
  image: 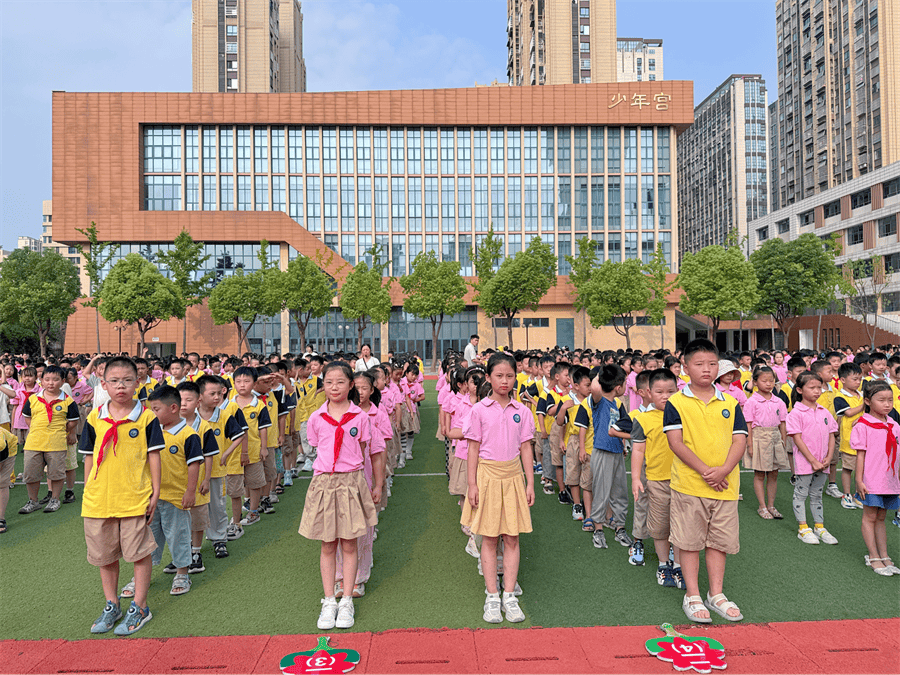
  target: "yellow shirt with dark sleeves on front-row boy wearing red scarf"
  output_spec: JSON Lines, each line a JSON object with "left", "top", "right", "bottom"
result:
{"left": 78, "top": 403, "right": 166, "bottom": 518}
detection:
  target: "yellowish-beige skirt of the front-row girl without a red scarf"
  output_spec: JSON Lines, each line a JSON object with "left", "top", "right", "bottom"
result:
{"left": 460, "top": 457, "right": 531, "bottom": 537}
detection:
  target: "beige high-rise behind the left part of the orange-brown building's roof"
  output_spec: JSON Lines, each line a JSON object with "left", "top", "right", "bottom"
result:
{"left": 191, "top": 0, "right": 306, "bottom": 93}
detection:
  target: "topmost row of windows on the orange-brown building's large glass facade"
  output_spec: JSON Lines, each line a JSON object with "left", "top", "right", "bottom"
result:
{"left": 144, "top": 126, "right": 671, "bottom": 175}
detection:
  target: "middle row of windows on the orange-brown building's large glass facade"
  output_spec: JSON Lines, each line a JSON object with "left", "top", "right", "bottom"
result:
{"left": 144, "top": 175, "right": 672, "bottom": 232}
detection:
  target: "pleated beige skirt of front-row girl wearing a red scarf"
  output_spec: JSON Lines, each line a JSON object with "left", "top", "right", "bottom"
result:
{"left": 299, "top": 470, "right": 378, "bottom": 541}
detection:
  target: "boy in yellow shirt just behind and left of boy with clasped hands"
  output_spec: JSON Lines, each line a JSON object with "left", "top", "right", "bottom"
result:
{"left": 631, "top": 368, "right": 685, "bottom": 588}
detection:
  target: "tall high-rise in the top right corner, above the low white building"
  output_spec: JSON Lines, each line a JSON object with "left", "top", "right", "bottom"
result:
{"left": 773, "top": 0, "right": 900, "bottom": 208}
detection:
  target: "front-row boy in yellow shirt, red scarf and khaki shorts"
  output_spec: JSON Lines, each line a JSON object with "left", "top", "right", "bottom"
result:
{"left": 79, "top": 357, "right": 165, "bottom": 635}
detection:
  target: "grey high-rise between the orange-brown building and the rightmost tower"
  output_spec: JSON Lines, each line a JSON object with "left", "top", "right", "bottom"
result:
{"left": 677, "top": 75, "right": 768, "bottom": 259}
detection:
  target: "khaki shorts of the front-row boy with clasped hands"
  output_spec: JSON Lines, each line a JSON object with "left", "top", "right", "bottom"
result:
{"left": 669, "top": 490, "right": 741, "bottom": 555}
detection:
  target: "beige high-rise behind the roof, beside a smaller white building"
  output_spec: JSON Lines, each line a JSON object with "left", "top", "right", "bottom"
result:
{"left": 506, "top": 0, "right": 616, "bottom": 86}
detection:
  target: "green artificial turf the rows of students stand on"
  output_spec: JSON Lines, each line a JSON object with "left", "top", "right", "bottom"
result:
{"left": 0, "top": 390, "right": 900, "bottom": 639}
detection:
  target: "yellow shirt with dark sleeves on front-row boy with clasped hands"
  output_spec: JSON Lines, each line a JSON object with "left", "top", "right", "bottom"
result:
{"left": 663, "top": 385, "right": 747, "bottom": 501}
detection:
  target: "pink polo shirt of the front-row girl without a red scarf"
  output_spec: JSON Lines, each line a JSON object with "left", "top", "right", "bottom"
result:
{"left": 462, "top": 398, "right": 534, "bottom": 462}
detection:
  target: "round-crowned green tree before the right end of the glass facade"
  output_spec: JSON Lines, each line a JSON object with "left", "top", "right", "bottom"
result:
{"left": 582, "top": 258, "right": 652, "bottom": 348}
